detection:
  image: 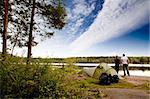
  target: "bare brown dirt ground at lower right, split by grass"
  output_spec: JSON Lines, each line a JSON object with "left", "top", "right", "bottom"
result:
{"left": 102, "top": 76, "right": 150, "bottom": 99}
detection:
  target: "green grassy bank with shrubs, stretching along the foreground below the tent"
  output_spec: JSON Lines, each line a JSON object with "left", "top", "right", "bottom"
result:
{"left": 0, "top": 57, "right": 149, "bottom": 99}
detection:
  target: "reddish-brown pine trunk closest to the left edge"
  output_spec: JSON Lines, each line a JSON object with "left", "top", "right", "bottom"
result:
{"left": 2, "top": 0, "right": 8, "bottom": 57}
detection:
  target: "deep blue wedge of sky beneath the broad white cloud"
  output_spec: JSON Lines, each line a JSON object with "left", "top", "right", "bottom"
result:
{"left": 94, "top": 24, "right": 150, "bottom": 56}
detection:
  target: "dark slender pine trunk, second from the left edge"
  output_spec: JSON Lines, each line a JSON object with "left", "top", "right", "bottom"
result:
{"left": 27, "top": 0, "right": 35, "bottom": 64}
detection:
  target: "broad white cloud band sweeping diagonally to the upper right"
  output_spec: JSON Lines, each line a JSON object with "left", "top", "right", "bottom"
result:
{"left": 70, "top": 0, "right": 149, "bottom": 52}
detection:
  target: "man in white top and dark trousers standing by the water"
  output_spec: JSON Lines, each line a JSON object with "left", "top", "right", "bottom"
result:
{"left": 121, "top": 54, "right": 130, "bottom": 76}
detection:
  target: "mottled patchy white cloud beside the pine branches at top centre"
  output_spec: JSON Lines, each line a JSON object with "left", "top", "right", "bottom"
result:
{"left": 63, "top": 0, "right": 96, "bottom": 39}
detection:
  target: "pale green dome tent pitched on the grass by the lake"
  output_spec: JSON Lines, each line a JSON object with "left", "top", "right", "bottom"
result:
{"left": 83, "top": 63, "right": 122, "bottom": 79}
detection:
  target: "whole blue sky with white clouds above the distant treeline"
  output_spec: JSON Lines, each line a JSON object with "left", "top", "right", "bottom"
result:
{"left": 2, "top": 0, "right": 150, "bottom": 57}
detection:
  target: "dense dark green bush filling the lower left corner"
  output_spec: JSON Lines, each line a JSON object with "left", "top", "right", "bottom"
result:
{"left": 0, "top": 57, "right": 61, "bottom": 98}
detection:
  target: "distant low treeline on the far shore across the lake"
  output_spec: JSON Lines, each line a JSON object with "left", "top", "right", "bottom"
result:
{"left": 36, "top": 56, "right": 150, "bottom": 64}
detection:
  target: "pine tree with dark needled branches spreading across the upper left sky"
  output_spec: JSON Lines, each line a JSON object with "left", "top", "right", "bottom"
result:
{"left": 0, "top": 0, "right": 67, "bottom": 62}
